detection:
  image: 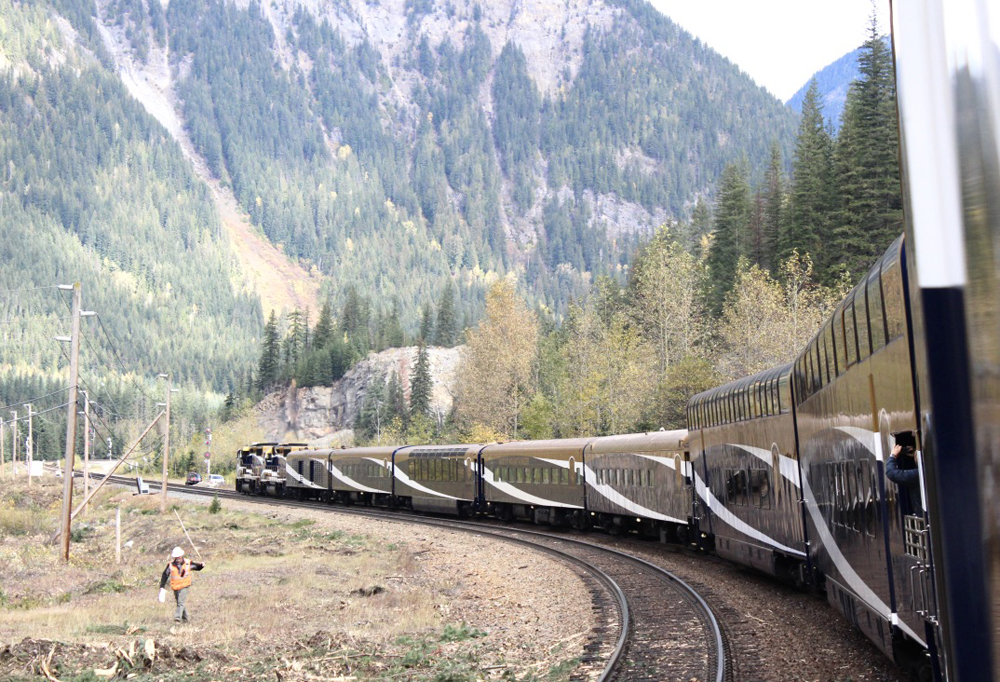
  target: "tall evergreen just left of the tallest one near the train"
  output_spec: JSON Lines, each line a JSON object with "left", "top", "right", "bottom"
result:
{"left": 778, "top": 78, "right": 832, "bottom": 278}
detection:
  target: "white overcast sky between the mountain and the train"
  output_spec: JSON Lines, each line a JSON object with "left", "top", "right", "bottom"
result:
{"left": 651, "top": 0, "right": 889, "bottom": 102}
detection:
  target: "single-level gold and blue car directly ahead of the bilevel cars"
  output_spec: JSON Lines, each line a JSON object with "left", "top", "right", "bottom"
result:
{"left": 584, "top": 429, "right": 693, "bottom": 541}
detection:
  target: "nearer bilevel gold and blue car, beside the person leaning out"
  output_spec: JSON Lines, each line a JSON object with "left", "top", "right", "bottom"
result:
{"left": 794, "top": 238, "right": 929, "bottom": 658}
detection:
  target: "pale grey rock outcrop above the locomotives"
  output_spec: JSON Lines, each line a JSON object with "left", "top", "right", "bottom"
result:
{"left": 257, "top": 346, "right": 462, "bottom": 446}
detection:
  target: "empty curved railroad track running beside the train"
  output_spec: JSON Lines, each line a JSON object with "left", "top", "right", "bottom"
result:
{"left": 88, "top": 474, "right": 733, "bottom": 682}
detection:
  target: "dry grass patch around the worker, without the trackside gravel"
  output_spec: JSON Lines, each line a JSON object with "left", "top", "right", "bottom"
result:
{"left": 0, "top": 479, "right": 580, "bottom": 680}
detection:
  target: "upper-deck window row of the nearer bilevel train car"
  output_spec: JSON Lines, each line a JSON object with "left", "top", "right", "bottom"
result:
{"left": 795, "top": 251, "right": 906, "bottom": 400}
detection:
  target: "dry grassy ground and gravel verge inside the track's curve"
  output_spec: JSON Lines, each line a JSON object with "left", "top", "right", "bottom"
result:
{"left": 0, "top": 479, "right": 593, "bottom": 682}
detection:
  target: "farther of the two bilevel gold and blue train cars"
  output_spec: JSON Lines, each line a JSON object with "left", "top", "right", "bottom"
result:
{"left": 688, "top": 364, "right": 808, "bottom": 581}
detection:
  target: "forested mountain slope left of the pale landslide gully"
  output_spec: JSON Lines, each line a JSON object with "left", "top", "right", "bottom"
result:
{"left": 0, "top": 4, "right": 262, "bottom": 389}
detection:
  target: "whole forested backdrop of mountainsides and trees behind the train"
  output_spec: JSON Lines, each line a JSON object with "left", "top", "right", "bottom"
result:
{"left": 0, "top": 0, "right": 902, "bottom": 473}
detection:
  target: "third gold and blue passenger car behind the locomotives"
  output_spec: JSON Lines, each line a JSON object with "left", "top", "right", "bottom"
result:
{"left": 392, "top": 445, "right": 482, "bottom": 516}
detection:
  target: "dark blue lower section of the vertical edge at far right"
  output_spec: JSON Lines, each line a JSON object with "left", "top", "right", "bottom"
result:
{"left": 921, "top": 288, "right": 994, "bottom": 682}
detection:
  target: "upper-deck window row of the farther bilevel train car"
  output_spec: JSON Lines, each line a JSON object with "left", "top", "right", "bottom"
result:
{"left": 688, "top": 374, "right": 792, "bottom": 429}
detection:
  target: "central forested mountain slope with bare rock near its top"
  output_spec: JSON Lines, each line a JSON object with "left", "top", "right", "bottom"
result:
{"left": 102, "top": 0, "right": 794, "bottom": 324}
